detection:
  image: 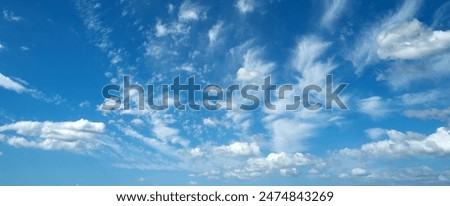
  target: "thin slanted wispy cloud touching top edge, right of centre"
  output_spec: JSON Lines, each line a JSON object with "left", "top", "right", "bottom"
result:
{"left": 320, "top": 0, "right": 347, "bottom": 28}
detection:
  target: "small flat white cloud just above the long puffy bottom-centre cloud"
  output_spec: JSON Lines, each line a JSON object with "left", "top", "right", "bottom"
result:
{"left": 212, "top": 142, "right": 260, "bottom": 157}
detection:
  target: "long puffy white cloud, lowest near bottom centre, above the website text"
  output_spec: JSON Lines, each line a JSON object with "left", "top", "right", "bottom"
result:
{"left": 225, "top": 152, "right": 312, "bottom": 179}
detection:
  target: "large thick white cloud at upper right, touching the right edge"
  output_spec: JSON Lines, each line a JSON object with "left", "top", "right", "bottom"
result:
{"left": 377, "top": 19, "right": 450, "bottom": 60}
